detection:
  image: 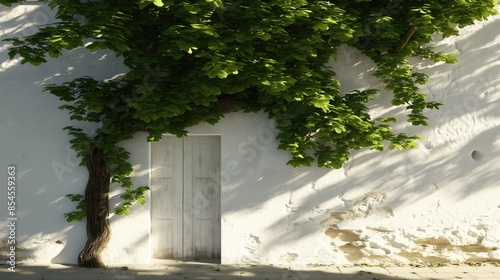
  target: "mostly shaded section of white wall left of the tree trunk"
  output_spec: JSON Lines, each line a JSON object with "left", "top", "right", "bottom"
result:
{"left": 0, "top": 3, "right": 128, "bottom": 263}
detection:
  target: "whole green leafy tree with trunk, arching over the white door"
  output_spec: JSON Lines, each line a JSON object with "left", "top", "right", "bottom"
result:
{"left": 0, "top": 0, "right": 497, "bottom": 267}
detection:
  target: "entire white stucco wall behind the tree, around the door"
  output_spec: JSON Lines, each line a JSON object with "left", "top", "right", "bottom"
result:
{"left": 0, "top": 2, "right": 500, "bottom": 264}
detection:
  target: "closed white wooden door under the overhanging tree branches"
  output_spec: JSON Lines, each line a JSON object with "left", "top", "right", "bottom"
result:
{"left": 151, "top": 136, "right": 221, "bottom": 259}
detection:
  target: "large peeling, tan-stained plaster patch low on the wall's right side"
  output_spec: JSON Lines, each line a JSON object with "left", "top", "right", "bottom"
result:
{"left": 320, "top": 192, "right": 500, "bottom": 263}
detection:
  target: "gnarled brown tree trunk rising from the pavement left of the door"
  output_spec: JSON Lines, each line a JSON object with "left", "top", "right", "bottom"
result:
{"left": 78, "top": 147, "right": 110, "bottom": 267}
